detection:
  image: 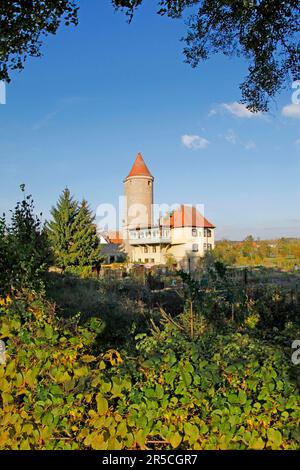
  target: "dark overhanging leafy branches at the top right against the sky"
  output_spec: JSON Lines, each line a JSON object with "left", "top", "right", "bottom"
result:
{"left": 113, "top": 0, "right": 300, "bottom": 112}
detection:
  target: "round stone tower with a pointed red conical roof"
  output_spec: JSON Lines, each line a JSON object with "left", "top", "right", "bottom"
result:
{"left": 124, "top": 153, "right": 154, "bottom": 230}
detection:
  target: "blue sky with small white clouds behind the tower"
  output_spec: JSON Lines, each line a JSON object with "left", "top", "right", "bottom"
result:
{"left": 0, "top": 0, "right": 300, "bottom": 239}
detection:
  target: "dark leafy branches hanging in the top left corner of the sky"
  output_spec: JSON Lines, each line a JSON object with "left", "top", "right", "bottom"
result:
{"left": 0, "top": 0, "right": 78, "bottom": 81}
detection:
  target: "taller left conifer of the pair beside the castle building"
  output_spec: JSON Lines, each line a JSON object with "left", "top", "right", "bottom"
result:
{"left": 47, "top": 188, "right": 79, "bottom": 270}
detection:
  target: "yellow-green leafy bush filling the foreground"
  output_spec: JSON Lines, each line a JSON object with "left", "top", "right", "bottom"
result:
{"left": 0, "top": 299, "right": 300, "bottom": 450}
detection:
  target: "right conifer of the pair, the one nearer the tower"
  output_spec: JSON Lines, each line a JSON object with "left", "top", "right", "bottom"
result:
{"left": 70, "top": 200, "right": 100, "bottom": 266}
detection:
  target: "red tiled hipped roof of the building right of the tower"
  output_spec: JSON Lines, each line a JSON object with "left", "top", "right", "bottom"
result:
{"left": 162, "top": 205, "right": 215, "bottom": 228}
